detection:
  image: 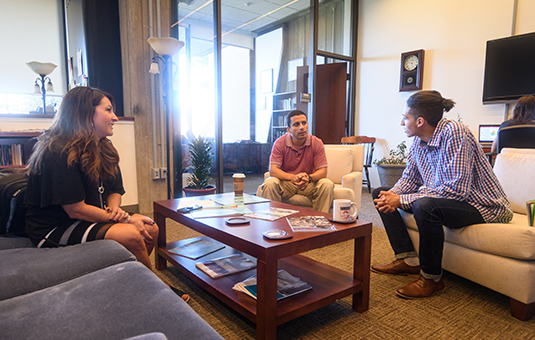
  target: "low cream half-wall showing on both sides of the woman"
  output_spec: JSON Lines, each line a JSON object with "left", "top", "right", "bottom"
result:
{"left": 0, "top": 116, "right": 138, "bottom": 206}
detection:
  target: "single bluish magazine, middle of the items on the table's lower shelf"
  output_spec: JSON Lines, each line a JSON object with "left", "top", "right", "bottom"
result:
{"left": 195, "top": 253, "right": 256, "bottom": 279}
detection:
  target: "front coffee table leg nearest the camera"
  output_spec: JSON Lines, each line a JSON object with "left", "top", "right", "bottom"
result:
{"left": 256, "top": 261, "right": 277, "bottom": 340}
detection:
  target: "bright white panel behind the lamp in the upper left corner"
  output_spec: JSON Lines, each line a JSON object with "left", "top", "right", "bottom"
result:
{"left": 0, "top": 0, "right": 66, "bottom": 95}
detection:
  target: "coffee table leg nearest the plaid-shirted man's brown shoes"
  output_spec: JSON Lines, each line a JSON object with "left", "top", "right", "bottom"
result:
{"left": 353, "top": 235, "right": 372, "bottom": 313}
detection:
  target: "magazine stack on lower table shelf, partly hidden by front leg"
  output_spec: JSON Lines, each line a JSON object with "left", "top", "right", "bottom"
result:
{"left": 232, "top": 269, "right": 312, "bottom": 300}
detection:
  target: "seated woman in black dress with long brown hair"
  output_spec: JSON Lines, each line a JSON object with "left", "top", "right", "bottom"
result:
{"left": 25, "top": 87, "right": 158, "bottom": 269}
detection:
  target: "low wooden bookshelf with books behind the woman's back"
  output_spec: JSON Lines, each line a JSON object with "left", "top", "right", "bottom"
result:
{"left": 0, "top": 131, "right": 42, "bottom": 169}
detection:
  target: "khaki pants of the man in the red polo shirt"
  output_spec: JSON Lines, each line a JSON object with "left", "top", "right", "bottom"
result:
{"left": 259, "top": 177, "right": 334, "bottom": 214}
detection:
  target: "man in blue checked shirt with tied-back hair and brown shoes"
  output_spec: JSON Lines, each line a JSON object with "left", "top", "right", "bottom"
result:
{"left": 372, "top": 91, "right": 513, "bottom": 299}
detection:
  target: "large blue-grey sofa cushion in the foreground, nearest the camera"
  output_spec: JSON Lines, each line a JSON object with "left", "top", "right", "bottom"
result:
{"left": 0, "top": 262, "right": 223, "bottom": 340}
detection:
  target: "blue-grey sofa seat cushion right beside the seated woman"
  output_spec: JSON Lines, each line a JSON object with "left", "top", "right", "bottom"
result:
{"left": 0, "top": 240, "right": 136, "bottom": 301}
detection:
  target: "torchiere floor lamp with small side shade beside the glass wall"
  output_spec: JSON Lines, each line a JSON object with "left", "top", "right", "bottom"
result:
{"left": 147, "top": 37, "right": 184, "bottom": 199}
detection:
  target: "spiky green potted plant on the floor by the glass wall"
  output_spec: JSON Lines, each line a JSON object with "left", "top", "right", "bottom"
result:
{"left": 184, "top": 136, "right": 216, "bottom": 197}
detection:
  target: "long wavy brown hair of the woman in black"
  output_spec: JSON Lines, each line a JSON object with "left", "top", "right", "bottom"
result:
{"left": 26, "top": 87, "right": 119, "bottom": 184}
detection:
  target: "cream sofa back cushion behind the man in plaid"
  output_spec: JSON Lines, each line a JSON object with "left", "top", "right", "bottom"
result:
{"left": 494, "top": 149, "right": 535, "bottom": 214}
